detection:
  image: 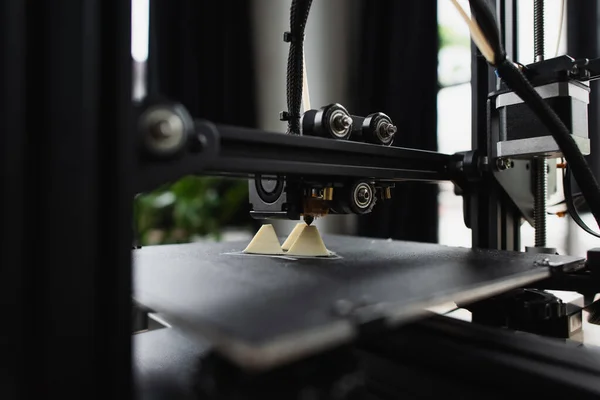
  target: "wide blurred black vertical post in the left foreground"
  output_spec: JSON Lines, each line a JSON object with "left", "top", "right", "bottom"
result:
{"left": 0, "top": 0, "right": 134, "bottom": 398}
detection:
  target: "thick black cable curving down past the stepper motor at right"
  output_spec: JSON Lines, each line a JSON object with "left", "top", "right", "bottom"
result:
{"left": 452, "top": 0, "right": 600, "bottom": 231}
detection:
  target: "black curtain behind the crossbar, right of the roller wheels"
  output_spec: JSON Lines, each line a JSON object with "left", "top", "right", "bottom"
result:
{"left": 350, "top": 0, "right": 438, "bottom": 242}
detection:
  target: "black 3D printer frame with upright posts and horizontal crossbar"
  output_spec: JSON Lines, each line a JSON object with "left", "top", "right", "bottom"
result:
{"left": 0, "top": 0, "right": 598, "bottom": 398}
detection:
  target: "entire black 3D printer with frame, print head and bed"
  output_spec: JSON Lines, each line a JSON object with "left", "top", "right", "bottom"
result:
{"left": 2, "top": 0, "right": 600, "bottom": 399}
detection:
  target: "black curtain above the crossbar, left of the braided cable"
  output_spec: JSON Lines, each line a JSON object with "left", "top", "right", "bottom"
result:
{"left": 148, "top": 0, "right": 256, "bottom": 127}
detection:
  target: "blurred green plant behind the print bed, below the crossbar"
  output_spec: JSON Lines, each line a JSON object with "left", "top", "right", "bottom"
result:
{"left": 134, "top": 176, "right": 251, "bottom": 245}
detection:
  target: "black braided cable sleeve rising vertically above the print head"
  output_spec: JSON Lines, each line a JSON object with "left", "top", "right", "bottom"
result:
{"left": 286, "top": 0, "right": 312, "bottom": 135}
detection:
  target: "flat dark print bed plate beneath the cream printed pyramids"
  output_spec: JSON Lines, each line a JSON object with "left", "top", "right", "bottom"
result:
{"left": 134, "top": 235, "right": 583, "bottom": 370}
